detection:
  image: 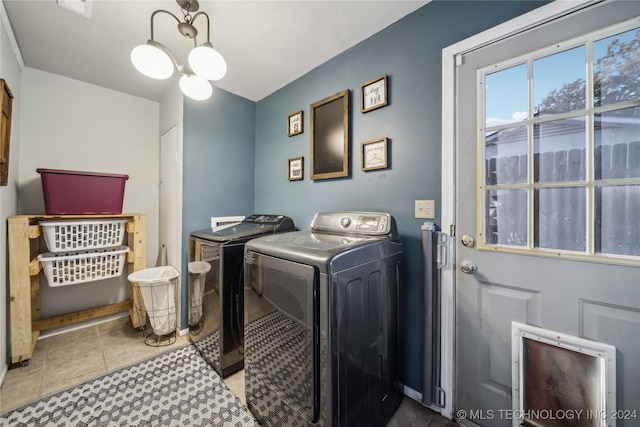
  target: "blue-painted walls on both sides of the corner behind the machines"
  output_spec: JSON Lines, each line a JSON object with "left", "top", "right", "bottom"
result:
{"left": 182, "top": 1, "right": 545, "bottom": 392}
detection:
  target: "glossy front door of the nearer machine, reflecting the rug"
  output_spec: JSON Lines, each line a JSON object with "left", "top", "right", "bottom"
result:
{"left": 245, "top": 251, "right": 320, "bottom": 425}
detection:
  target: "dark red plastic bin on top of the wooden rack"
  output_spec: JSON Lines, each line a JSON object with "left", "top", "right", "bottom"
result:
{"left": 36, "top": 169, "right": 129, "bottom": 215}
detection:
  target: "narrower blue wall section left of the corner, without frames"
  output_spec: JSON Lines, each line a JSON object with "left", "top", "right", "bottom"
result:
{"left": 181, "top": 87, "right": 256, "bottom": 325}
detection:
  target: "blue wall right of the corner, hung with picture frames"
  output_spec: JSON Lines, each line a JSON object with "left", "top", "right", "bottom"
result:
{"left": 255, "top": 1, "right": 544, "bottom": 391}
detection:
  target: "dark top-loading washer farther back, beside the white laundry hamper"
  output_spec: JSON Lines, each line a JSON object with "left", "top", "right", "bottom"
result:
{"left": 188, "top": 214, "right": 296, "bottom": 378}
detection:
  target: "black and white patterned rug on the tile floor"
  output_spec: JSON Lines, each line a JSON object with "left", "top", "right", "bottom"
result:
{"left": 0, "top": 345, "right": 260, "bottom": 427}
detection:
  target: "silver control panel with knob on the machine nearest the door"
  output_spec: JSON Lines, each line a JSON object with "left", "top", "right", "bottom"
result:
{"left": 311, "top": 211, "right": 395, "bottom": 236}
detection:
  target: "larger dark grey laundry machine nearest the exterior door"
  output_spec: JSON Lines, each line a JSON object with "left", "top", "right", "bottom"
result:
{"left": 244, "top": 212, "right": 403, "bottom": 427}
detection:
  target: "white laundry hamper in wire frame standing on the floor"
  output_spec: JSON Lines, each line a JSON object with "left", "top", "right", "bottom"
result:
{"left": 127, "top": 266, "right": 179, "bottom": 347}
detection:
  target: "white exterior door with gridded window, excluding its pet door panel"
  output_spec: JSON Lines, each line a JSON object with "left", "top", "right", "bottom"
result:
{"left": 454, "top": 1, "right": 640, "bottom": 426}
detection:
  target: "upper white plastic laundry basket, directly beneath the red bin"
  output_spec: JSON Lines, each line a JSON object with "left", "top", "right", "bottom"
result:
{"left": 40, "top": 219, "right": 127, "bottom": 252}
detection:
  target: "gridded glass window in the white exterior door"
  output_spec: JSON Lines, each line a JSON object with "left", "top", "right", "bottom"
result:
{"left": 478, "top": 19, "right": 640, "bottom": 262}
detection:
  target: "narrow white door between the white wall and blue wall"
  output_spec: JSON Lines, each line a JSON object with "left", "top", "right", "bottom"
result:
{"left": 159, "top": 126, "right": 181, "bottom": 271}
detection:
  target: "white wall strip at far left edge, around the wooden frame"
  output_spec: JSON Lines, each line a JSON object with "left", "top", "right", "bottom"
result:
{"left": 0, "top": 2, "right": 22, "bottom": 384}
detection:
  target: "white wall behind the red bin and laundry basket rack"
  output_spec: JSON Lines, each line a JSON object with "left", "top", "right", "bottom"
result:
{"left": 19, "top": 68, "right": 159, "bottom": 318}
